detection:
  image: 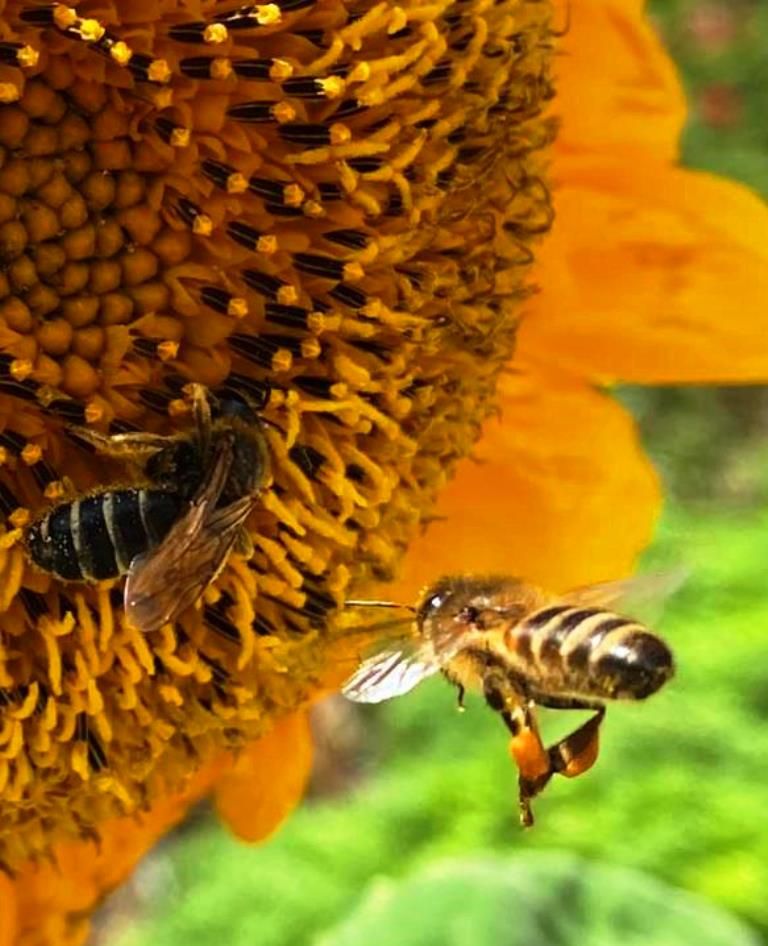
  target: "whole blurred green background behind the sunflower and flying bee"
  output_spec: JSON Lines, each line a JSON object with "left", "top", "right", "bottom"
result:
{"left": 100, "top": 0, "right": 768, "bottom": 946}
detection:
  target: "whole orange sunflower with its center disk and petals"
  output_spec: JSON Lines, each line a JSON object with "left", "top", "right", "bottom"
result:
{"left": 0, "top": 0, "right": 768, "bottom": 943}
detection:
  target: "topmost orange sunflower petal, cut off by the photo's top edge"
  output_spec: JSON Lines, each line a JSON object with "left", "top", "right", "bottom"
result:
{"left": 555, "top": 0, "right": 686, "bottom": 161}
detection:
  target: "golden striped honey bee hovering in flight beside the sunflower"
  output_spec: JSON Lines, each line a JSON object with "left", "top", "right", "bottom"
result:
{"left": 342, "top": 575, "right": 680, "bottom": 827}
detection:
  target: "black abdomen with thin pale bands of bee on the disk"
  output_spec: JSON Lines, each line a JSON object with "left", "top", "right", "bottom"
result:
{"left": 26, "top": 489, "right": 186, "bottom": 581}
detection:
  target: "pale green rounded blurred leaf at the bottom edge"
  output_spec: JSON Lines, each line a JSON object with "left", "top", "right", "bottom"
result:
{"left": 317, "top": 854, "right": 758, "bottom": 946}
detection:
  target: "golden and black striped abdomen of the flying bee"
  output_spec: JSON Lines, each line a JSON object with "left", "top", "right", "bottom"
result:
{"left": 508, "top": 604, "right": 674, "bottom": 700}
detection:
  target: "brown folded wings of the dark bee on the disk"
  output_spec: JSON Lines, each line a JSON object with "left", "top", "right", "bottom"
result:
{"left": 124, "top": 440, "right": 253, "bottom": 633}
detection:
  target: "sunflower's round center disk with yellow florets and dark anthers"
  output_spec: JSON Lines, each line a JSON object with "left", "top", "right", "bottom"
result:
{"left": 0, "top": 0, "right": 553, "bottom": 865}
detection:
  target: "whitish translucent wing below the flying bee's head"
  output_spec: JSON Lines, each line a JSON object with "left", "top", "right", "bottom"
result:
{"left": 341, "top": 639, "right": 441, "bottom": 703}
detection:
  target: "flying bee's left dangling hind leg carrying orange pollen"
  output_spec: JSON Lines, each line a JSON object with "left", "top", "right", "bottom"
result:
{"left": 483, "top": 668, "right": 554, "bottom": 828}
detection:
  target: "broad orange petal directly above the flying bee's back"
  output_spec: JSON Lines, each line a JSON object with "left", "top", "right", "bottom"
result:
{"left": 396, "top": 371, "right": 660, "bottom": 600}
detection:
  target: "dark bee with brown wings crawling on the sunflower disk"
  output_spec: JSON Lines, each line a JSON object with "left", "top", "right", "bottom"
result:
{"left": 25, "top": 384, "right": 269, "bottom": 632}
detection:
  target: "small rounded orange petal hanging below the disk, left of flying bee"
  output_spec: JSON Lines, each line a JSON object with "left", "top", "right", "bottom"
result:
{"left": 215, "top": 713, "right": 312, "bottom": 841}
